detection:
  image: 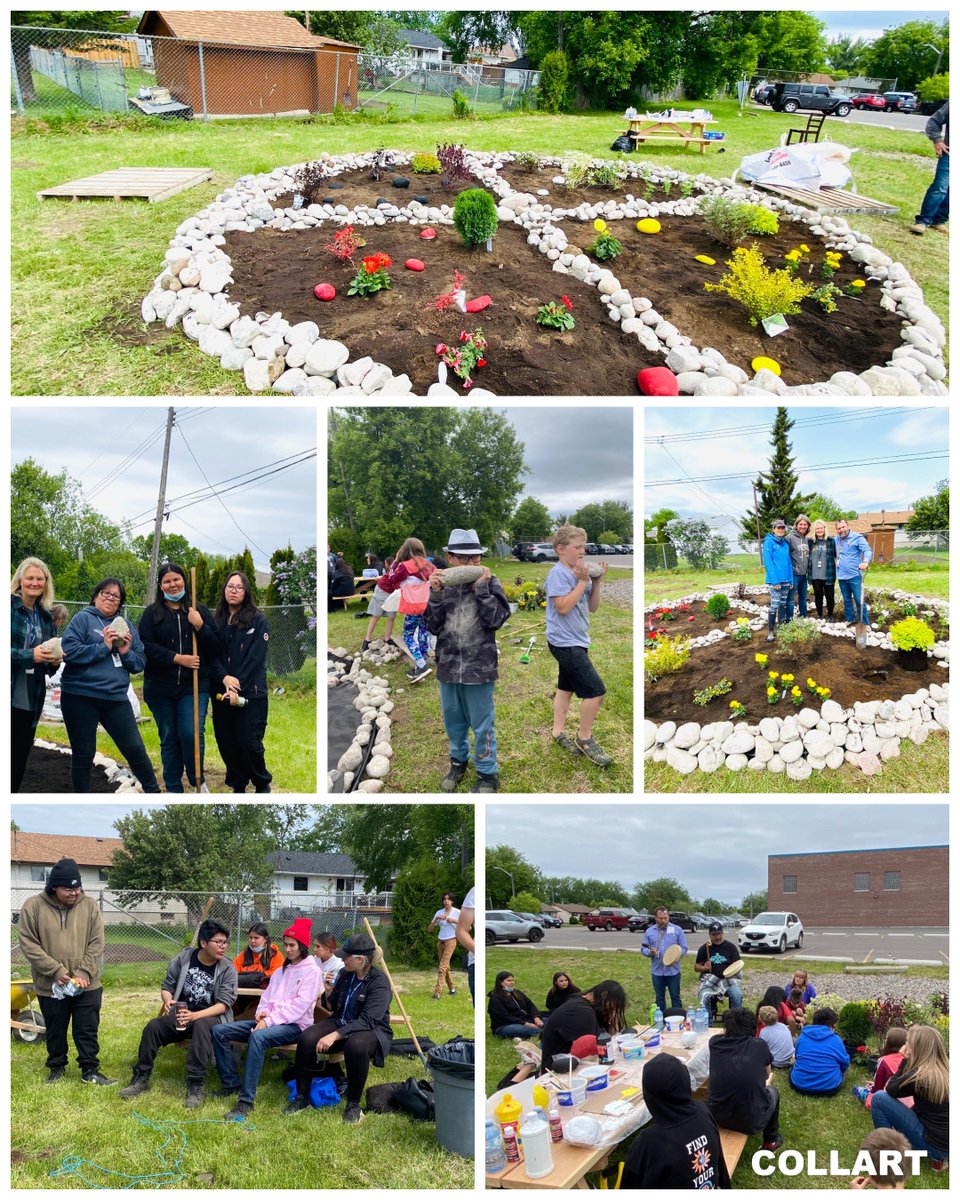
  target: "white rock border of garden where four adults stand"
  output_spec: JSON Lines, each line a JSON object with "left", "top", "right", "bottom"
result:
{"left": 643, "top": 587, "right": 950, "bottom": 782}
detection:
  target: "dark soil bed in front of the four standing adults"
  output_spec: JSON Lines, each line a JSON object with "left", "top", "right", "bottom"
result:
{"left": 643, "top": 633, "right": 948, "bottom": 725}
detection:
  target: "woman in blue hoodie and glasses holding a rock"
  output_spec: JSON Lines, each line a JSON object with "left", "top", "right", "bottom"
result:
{"left": 60, "top": 578, "right": 160, "bottom": 792}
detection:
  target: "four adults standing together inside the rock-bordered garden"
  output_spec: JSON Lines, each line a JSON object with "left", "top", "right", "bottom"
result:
{"left": 763, "top": 512, "right": 874, "bottom": 642}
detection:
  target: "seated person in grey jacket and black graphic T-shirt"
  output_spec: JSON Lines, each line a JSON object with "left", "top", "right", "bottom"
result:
{"left": 120, "top": 920, "right": 236, "bottom": 1109}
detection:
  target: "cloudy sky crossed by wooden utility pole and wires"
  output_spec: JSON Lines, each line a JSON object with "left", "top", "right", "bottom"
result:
{"left": 11, "top": 404, "right": 317, "bottom": 570}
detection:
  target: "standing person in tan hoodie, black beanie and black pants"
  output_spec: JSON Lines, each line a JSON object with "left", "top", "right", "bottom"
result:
{"left": 17, "top": 858, "right": 116, "bottom": 1086}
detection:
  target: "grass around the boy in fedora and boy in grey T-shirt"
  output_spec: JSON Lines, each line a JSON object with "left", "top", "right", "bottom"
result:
{"left": 328, "top": 559, "right": 634, "bottom": 794}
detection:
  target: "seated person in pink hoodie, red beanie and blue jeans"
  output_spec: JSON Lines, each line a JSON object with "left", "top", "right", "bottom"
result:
{"left": 212, "top": 917, "right": 323, "bottom": 1121}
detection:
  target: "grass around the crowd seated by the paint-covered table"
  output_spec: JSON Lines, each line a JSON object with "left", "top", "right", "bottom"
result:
{"left": 478, "top": 948, "right": 949, "bottom": 1190}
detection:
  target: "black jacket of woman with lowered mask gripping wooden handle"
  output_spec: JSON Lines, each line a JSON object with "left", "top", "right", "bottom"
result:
{"left": 138, "top": 605, "right": 223, "bottom": 704}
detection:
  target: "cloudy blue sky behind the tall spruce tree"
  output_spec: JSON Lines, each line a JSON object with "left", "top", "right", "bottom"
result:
{"left": 643, "top": 404, "right": 949, "bottom": 528}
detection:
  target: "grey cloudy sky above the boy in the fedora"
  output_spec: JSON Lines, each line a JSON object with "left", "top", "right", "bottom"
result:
{"left": 497, "top": 404, "right": 634, "bottom": 516}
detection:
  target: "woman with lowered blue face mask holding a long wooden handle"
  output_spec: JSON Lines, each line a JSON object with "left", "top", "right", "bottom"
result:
{"left": 139, "top": 563, "right": 220, "bottom": 792}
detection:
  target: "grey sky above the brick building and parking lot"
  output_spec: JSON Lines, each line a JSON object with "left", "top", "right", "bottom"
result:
{"left": 486, "top": 799, "right": 949, "bottom": 905}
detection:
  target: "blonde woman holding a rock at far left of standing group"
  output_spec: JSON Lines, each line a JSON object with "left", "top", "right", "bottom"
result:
{"left": 10, "top": 558, "right": 60, "bottom": 792}
